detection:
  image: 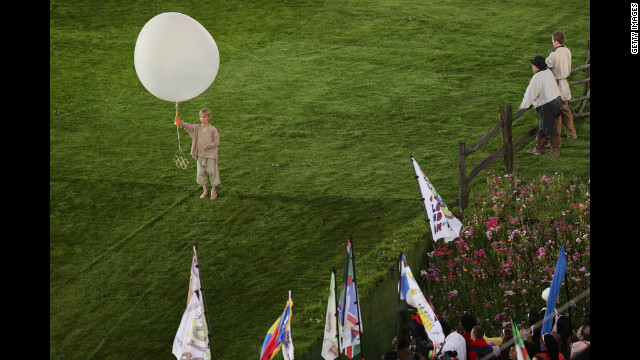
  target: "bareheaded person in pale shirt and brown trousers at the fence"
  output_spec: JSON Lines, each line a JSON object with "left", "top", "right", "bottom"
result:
{"left": 545, "top": 31, "right": 578, "bottom": 140}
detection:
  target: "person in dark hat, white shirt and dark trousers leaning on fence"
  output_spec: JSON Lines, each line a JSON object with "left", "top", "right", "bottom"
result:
{"left": 520, "top": 55, "right": 562, "bottom": 156}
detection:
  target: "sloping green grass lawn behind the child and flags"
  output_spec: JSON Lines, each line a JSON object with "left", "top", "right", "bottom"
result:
{"left": 50, "top": 0, "right": 590, "bottom": 360}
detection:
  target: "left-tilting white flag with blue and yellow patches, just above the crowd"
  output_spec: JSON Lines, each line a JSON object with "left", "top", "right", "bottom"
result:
{"left": 398, "top": 254, "right": 445, "bottom": 353}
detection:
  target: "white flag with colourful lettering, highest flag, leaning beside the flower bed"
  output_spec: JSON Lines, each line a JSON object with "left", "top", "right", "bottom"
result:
{"left": 411, "top": 157, "right": 462, "bottom": 242}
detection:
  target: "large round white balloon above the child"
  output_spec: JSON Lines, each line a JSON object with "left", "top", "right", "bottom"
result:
{"left": 134, "top": 12, "right": 220, "bottom": 102}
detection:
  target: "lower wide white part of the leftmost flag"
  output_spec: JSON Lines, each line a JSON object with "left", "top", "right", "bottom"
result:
{"left": 171, "top": 295, "right": 211, "bottom": 360}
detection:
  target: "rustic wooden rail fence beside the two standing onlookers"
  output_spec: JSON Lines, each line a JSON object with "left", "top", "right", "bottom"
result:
{"left": 458, "top": 40, "right": 591, "bottom": 209}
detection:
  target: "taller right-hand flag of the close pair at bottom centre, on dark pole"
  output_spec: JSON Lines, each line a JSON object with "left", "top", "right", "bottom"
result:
{"left": 338, "top": 238, "right": 362, "bottom": 359}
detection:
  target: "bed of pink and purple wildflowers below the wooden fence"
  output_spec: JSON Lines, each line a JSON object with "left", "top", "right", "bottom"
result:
{"left": 421, "top": 171, "right": 591, "bottom": 336}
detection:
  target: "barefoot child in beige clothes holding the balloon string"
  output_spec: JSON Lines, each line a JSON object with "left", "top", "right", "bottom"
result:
{"left": 176, "top": 108, "right": 220, "bottom": 200}
